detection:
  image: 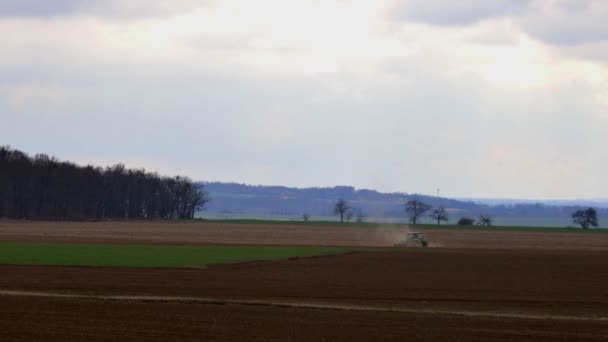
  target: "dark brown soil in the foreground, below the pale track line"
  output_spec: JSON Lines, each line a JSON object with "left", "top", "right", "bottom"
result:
{"left": 0, "top": 297, "right": 608, "bottom": 342}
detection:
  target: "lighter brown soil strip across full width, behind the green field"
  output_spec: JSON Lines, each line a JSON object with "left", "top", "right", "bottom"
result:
{"left": 0, "top": 220, "right": 608, "bottom": 251}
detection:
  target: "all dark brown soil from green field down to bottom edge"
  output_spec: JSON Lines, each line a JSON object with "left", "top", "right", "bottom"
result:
{"left": 0, "top": 249, "right": 608, "bottom": 341}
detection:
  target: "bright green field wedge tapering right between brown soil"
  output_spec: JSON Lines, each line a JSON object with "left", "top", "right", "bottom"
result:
{"left": 0, "top": 242, "right": 361, "bottom": 267}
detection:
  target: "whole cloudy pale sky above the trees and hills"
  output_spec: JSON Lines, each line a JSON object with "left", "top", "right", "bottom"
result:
{"left": 0, "top": 0, "right": 608, "bottom": 199}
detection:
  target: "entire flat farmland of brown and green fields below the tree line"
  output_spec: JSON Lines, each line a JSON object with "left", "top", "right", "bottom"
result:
{"left": 0, "top": 221, "right": 608, "bottom": 341}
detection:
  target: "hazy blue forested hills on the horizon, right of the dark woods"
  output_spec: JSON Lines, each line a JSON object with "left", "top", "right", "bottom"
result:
{"left": 199, "top": 182, "right": 608, "bottom": 221}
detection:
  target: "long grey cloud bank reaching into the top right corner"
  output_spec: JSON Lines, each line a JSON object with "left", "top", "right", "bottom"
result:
{"left": 390, "top": 0, "right": 608, "bottom": 45}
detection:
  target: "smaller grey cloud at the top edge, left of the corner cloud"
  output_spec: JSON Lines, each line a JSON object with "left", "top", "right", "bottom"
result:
{"left": 390, "top": 0, "right": 530, "bottom": 26}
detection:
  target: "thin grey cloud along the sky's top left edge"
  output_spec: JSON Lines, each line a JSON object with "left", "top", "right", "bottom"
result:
{"left": 0, "top": 0, "right": 210, "bottom": 18}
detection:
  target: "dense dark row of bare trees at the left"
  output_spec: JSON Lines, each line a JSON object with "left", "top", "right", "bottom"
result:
{"left": 0, "top": 146, "right": 209, "bottom": 220}
